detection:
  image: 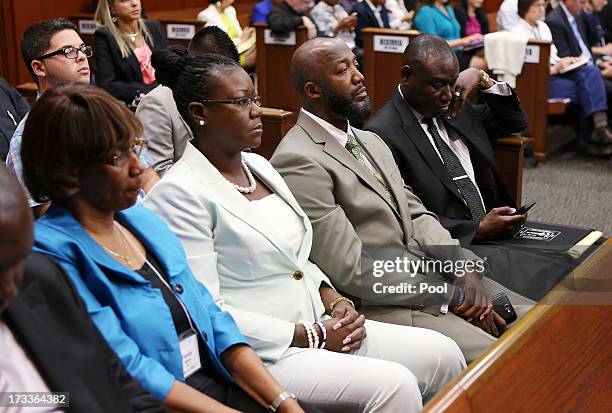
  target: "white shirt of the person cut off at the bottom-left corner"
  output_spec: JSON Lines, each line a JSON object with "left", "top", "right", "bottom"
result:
{"left": 0, "top": 320, "right": 59, "bottom": 413}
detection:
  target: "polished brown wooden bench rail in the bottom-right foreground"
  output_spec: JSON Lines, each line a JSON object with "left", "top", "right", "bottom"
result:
{"left": 423, "top": 239, "right": 612, "bottom": 413}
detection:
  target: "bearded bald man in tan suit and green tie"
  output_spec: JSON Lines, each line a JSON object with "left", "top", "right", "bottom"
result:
{"left": 271, "top": 38, "right": 531, "bottom": 362}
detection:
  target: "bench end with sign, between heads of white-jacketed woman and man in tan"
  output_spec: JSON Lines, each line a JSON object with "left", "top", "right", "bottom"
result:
{"left": 255, "top": 23, "right": 308, "bottom": 111}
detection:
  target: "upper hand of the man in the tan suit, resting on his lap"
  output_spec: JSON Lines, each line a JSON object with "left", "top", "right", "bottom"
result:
{"left": 450, "top": 272, "right": 493, "bottom": 322}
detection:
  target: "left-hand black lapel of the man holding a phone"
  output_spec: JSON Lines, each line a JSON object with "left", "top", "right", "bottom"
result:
{"left": 393, "top": 90, "right": 463, "bottom": 202}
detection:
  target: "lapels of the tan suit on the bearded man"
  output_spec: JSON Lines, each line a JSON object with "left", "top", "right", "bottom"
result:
{"left": 296, "top": 112, "right": 397, "bottom": 212}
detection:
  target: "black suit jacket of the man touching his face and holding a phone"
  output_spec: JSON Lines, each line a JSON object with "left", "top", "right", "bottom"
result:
{"left": 366, "top": 89, "right": 527, "bottom": 246}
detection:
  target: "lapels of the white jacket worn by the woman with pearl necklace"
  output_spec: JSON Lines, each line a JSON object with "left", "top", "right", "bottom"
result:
{"left": 182, "top": 143, "right": 296, "bottom": 261}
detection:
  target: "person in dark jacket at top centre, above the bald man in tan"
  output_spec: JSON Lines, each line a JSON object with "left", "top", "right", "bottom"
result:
{"left": 268, "top": 0, "right": 322, "bottom": 39}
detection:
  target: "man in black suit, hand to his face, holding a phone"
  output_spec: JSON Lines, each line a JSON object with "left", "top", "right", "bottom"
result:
{"left": 366, "top": 35, "right": 527, "bottom": 246}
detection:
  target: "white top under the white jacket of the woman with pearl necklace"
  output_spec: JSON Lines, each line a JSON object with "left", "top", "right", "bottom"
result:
{"left": 251, "top": 194, "right": 306, "bottom": 256}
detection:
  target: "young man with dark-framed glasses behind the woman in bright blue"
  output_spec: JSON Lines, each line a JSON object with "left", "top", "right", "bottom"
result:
{"left": 6, "top": 18, "right": 159, "bottom": 216}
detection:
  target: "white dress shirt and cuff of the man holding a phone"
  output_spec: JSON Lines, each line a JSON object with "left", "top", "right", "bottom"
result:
{"left": 397, "top": 79, "right": 512, "bottom": 213}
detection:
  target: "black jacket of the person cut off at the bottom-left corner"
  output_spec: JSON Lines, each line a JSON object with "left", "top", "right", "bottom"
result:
{"left": 2, "top": 253, "right": 166, "bottom": 413}
